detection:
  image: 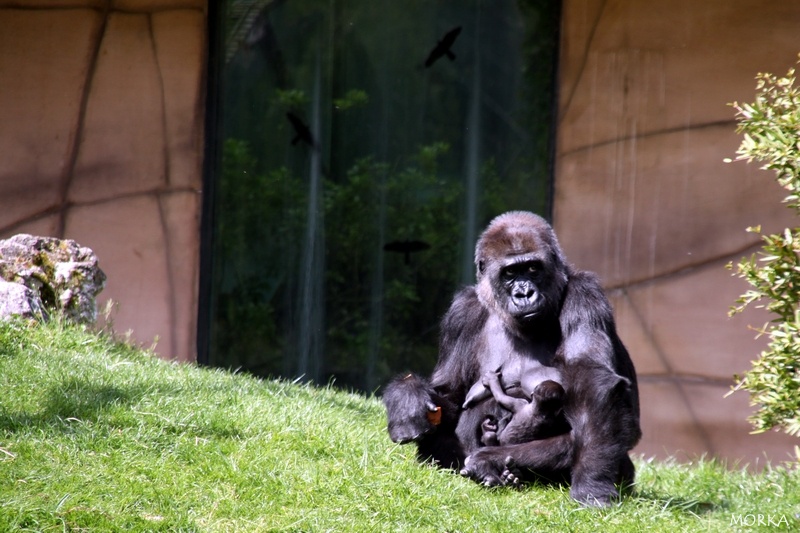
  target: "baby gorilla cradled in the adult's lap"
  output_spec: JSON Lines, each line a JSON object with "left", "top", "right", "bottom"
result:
{"left": 481, "top": 372, "right": 570, "bottom": 446}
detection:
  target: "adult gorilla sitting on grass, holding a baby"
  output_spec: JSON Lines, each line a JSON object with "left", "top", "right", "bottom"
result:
{"left": 384, "top": 211, "right": 641, "bottom": 505}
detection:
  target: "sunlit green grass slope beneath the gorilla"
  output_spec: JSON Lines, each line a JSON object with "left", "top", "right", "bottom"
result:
{"left": 0, "top": 322, "right": 800, "bottom": 533}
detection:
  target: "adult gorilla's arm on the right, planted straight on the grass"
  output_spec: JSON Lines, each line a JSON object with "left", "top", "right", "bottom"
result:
{"left": 561, "top": 272, "right": 642, "bottom": 504}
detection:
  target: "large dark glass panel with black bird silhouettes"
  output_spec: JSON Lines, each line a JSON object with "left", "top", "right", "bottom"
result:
{"left": 201, "top": 0, "right": 559, "bottom": 390}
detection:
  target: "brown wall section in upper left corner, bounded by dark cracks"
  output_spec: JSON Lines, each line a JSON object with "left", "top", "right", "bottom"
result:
{"left": 0, "top": 9, "right": 101, "bottom": 230}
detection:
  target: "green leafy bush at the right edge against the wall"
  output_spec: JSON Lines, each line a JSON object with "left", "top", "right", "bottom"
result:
{"left": 729, "top": 55, "right": 800, "bottom": 435}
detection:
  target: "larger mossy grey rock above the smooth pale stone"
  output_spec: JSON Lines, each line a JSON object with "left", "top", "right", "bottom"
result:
{"left": 0, "top": 233, "right": 106, "bottom": 324}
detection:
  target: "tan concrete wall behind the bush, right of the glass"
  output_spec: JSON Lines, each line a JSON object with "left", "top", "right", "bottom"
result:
{"left": 554, "top": 0, "right": 800, "bottom": 463}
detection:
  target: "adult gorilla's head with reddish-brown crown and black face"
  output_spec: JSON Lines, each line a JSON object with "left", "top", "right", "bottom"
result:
{"left": 475, "top": 211, "right": 569, "bottom": 330}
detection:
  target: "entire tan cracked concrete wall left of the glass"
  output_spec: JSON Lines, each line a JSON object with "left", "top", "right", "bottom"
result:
{"left": 0, "top": 0, "right": 206, "bottom": 360}
